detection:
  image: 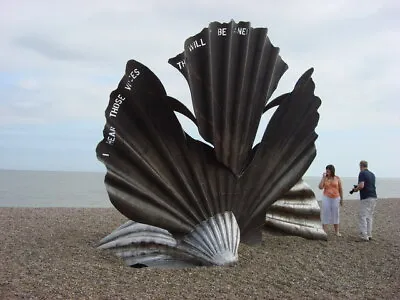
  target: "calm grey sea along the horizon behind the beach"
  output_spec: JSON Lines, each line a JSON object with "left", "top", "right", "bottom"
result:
{"left": 0, "top": 170, "right": 400, "bottom": 207}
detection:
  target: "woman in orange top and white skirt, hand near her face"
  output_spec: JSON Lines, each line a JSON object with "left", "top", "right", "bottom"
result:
{"left": 318, "top": 165, "right": 343, "bottom": 236}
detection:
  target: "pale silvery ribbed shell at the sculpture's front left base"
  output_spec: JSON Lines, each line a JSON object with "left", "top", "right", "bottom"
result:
{"left": 98, "top": 212, "right": 240, "bottom": 268}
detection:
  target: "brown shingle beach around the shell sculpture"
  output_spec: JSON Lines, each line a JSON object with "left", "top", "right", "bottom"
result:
{"left": 0, "top": 199, "right": 400, "bottom": 299}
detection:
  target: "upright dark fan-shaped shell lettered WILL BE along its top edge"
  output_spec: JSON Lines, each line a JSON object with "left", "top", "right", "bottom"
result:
{"left": 169, "top": 21, "right": 288, "bottom": 176}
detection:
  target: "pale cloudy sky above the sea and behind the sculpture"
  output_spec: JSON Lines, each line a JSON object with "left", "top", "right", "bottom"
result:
{"left": 0, "top": 0, "right": 400, "bottom": 177}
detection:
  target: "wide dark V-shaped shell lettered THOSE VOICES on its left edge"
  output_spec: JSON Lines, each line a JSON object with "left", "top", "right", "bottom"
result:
{"left": 97, "top": 61, "right": 320, "bottom": 242}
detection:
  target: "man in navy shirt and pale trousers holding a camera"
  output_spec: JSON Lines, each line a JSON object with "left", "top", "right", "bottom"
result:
{"left": 353, "top": 160, "right": 378, "bottom": 241}
